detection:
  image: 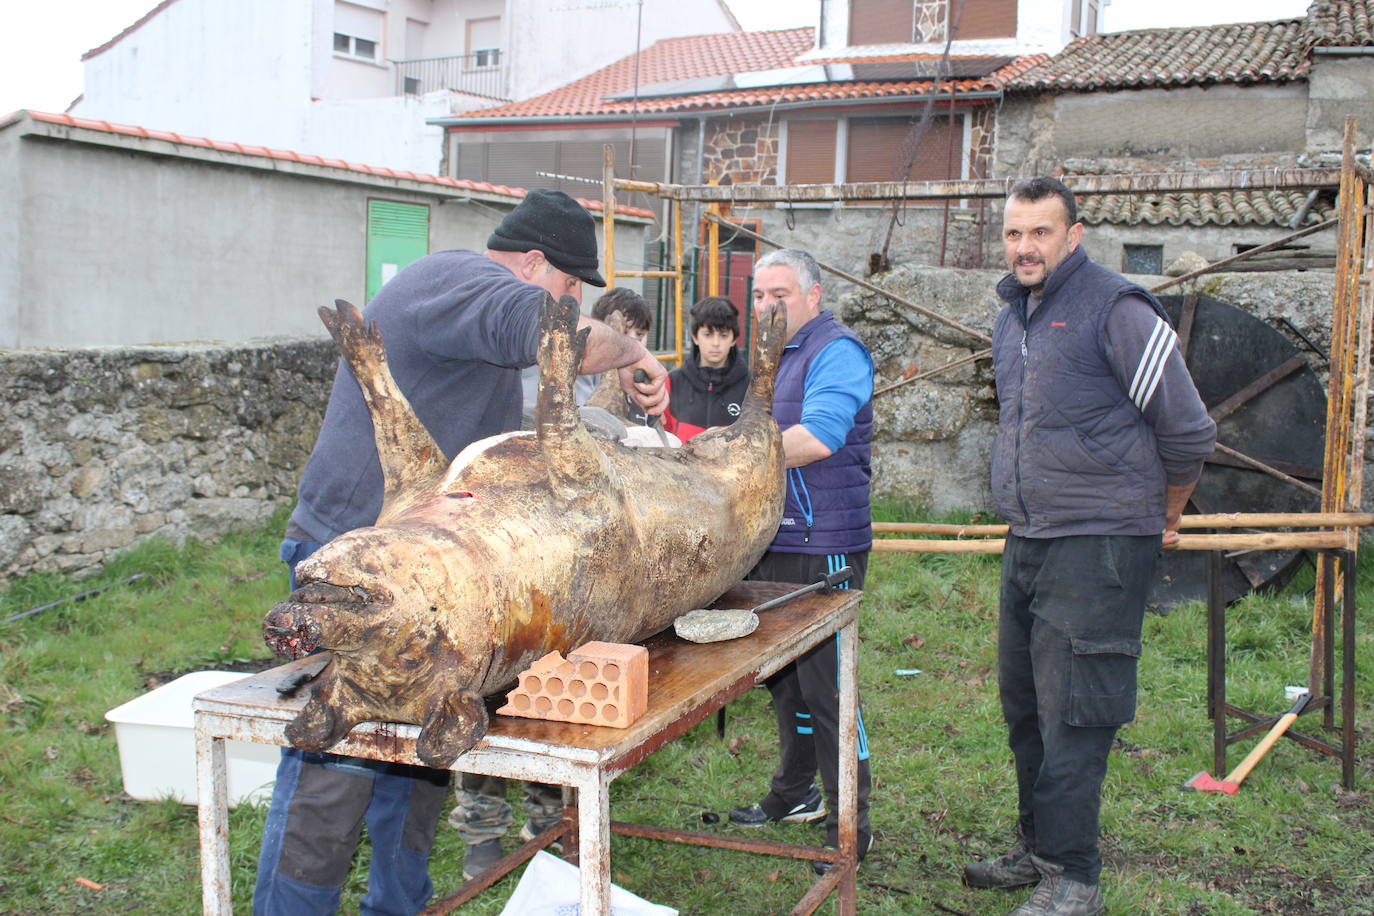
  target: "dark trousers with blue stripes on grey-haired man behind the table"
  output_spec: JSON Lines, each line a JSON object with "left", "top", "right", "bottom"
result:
{"left": 745, "top": 551, "right": 872, "bottom": 851}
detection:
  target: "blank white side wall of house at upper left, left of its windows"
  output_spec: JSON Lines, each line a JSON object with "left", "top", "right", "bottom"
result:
{"left": 73, "top": 0, "right": 315, "bottom": 148}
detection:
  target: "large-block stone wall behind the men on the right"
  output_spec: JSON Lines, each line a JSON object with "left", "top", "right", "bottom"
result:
{"left": 837, "top": 264, "right": 1374, "bottom": 512}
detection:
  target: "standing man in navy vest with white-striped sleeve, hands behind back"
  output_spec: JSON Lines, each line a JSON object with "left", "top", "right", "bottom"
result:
{"left": 963, "top": 179, "right": 1216, "bottom": 916}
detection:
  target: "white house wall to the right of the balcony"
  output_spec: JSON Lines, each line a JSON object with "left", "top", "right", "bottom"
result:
{"left": 510, "top": 0, "right": 734, "bottom": 99}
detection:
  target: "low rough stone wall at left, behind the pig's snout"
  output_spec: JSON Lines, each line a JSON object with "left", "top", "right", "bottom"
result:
{"left": 0, "top": 341, "right": 337, "bottom": 582}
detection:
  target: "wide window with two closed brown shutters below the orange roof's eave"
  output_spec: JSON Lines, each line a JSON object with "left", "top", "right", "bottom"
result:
{"left": 785, "top": 115, "right": 966, "bottom": 203}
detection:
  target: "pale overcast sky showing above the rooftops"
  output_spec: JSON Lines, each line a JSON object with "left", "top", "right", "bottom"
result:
{"left": 0, "top": 0, "right": 1308, "bottom": 120}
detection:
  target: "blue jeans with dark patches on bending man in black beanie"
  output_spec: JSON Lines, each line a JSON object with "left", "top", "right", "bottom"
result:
{"left": 253, "top": 538, "right": 449, "bottom": 916}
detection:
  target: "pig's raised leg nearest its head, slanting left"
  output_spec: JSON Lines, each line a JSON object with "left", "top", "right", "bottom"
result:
{"left": 320, "top": 299, "right": 448, "bottom": 522}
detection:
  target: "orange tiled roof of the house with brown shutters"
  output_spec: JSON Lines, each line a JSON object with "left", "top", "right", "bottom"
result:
{"left": 455, "top": 29, "right": 1044, "bottom": 124}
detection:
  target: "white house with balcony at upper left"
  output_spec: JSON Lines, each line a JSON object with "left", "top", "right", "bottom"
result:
{"left": 69, "top": 0, "right": 739, "bottom": 173}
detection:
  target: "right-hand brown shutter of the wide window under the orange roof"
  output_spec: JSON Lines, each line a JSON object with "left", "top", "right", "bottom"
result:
{"left": 845, "top": 118, "right": 963, "bottom": 205}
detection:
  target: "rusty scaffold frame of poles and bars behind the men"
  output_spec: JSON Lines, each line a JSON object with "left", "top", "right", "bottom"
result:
{"left": 603, "top": 118, "right": 1374, "bottom": 786}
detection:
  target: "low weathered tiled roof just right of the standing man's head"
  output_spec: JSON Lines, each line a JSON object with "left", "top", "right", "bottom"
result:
{"left": 1063, "top": 159, "right": 1336, "bottom": 228}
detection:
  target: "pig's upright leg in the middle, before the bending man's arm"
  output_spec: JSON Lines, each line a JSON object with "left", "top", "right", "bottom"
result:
{"left": 534, "top": 294, "right": 610, "bottom": 500}
